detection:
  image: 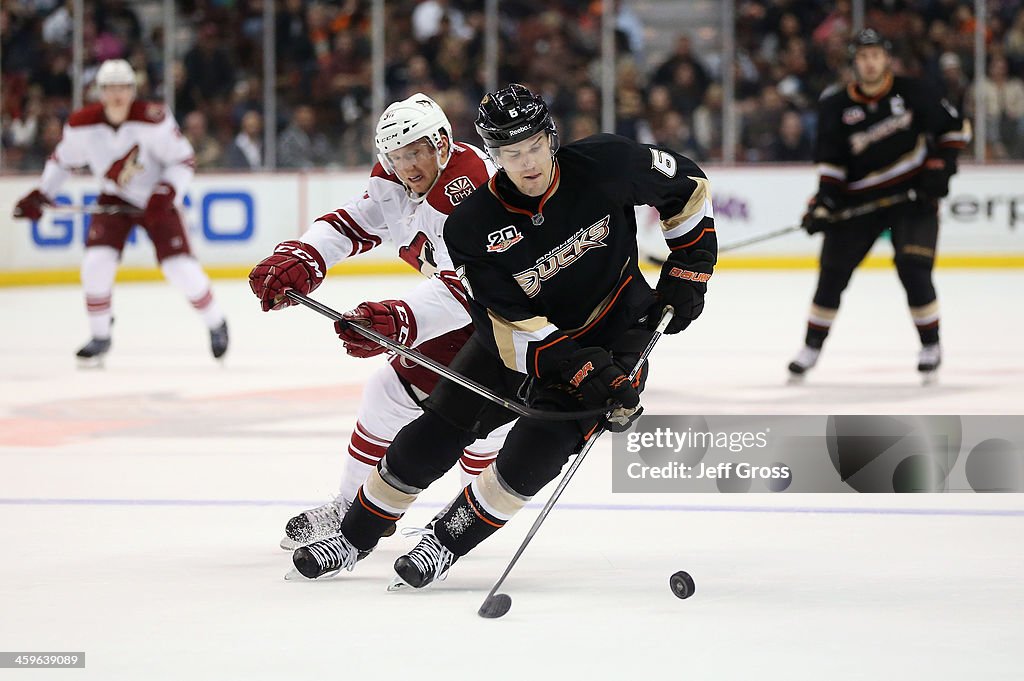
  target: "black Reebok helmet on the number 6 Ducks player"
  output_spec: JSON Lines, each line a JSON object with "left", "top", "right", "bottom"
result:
{"left": 476, "top": 83, "right": 558, "bottom": 154}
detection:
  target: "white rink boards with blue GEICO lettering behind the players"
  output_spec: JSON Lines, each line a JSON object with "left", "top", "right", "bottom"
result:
{"left": 0, "top": 166, "right": 1024, "bottom": 271}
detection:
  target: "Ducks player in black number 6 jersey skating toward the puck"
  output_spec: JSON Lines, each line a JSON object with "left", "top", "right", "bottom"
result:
{"left": 293, "top": 85, "right": 718, "bottom": 587}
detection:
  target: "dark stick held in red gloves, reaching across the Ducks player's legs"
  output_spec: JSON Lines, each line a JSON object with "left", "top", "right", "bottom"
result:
{"left": 285, "top": 289, "right": 608, "bottom": 421}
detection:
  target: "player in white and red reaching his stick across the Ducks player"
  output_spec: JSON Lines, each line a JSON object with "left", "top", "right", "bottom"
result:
{"left": 249, "top": 93, "right": 511, "bottom": 549}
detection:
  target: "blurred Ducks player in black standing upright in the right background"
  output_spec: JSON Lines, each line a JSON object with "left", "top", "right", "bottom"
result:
{"left": 790, "top": 29, "right": 971, "bottom": 378}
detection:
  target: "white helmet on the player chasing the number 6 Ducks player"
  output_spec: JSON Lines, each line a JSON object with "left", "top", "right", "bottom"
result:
{"left": 374, "top": 92, "right": 455, "bottom": 173}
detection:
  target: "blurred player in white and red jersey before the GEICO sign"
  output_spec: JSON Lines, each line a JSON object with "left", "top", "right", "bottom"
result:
{"left": 14, "top": 59, "right": 227, "bottom": 360}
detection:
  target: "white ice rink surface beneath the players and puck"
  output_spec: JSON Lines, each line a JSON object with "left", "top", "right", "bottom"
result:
{"left": 0, "top": 270, "right": 1024, "bottom": 681}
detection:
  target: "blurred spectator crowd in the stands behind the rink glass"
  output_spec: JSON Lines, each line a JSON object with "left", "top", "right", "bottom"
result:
{"left": 0, "top": 0, "right": 1024, "bottom": 172}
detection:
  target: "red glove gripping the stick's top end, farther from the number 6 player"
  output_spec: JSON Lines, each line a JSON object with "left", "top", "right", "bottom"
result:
{"left": 249, "top": 241, "right": 327, "bottom": 312}
